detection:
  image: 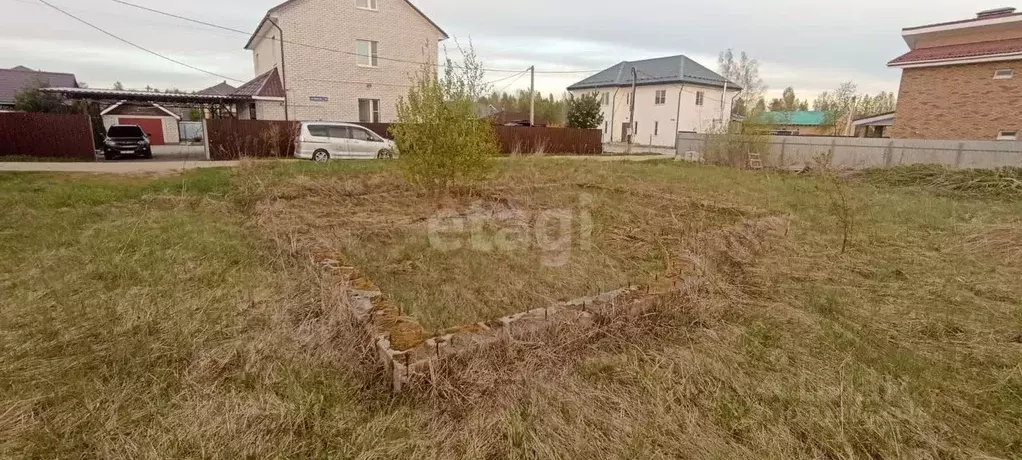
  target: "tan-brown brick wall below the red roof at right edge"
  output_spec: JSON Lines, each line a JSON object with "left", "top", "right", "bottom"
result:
{"left": 890, "top": 60, "right": 1022, "bottom": 140}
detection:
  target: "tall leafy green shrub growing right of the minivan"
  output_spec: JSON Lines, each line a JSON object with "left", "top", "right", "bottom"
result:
{"left": 390, "top": 39, "right": 500, "bottom": 192}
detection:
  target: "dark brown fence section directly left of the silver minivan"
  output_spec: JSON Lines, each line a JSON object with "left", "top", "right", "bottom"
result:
{"left": 205, "top": 119, "right": 298, "bottom": 160}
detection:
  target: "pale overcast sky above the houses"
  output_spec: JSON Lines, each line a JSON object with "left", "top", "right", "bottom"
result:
{"left": 0, "top": 0, "right": 989, "bottom": 99}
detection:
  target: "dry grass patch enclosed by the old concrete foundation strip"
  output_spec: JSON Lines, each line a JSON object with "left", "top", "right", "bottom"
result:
{"left": 259, "top": 163, "right": 745, "bottom": 333}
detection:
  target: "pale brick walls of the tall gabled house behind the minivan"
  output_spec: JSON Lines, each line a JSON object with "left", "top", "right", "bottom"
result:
{"left": 252, "top": 0, "right": 443, "bottom": 123}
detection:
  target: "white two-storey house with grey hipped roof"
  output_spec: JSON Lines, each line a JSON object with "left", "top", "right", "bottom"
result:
{"left": 568, "top": 55, "right": 741, "bottom": 146}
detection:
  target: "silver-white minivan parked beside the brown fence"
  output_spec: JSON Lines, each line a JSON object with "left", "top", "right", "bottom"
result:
{"left": 294, "top": 122, "right": 398, "bottom": 162}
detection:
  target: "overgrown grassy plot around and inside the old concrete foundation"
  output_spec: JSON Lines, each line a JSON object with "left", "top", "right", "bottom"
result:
{"left": 0, "top": 159, "right": 1022, "bottom": 459}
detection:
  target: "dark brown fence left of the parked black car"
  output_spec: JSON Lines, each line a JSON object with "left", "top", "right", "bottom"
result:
{"left": 0, "top": 112, "right": 96, "bottom": 162}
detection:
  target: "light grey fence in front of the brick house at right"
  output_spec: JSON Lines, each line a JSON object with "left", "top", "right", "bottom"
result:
{"left": 677, "top": 133, "right": 1022, "bottom": 170}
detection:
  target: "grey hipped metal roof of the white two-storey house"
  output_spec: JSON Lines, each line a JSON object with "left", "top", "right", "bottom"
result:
{"left": 568, "top": 54, "right": 742, "bottom": 90}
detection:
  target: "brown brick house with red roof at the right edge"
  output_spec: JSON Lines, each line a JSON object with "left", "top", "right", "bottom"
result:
{"left": 888, "top": 8, "right": 1022, "bottom": 140}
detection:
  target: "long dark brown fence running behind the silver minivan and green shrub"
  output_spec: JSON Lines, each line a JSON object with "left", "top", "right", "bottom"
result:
{"left": 205, "top": 119, "right": 603, "bottom": 160}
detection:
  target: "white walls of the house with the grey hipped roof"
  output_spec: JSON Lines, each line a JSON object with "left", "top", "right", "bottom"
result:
{"left": 571, "top": 84, "right": 739, "bottom": 146}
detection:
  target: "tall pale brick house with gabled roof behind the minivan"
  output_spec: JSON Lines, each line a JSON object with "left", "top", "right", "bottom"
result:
{"left": 237, "top": 0, "right": 448, "bottom": 123}
